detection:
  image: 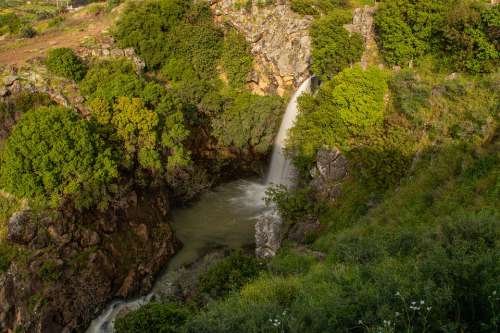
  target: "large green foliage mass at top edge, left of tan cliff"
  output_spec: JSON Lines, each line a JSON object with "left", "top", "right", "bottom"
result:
{"left": 114, "top": 0, "right": 222, "bottom": 73}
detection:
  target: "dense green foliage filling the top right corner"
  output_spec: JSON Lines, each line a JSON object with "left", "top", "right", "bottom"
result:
{"left": 375, "top": 0, "right": 500, "bottom": 73}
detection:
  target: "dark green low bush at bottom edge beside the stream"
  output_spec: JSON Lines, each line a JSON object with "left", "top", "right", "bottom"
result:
{"left": 115, "top": 303, "right": 190, "bottom": 333}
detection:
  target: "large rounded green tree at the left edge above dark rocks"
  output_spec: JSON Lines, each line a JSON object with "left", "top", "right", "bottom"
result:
{"left": 0, "top": 107, "right": 118, "bottom": 208}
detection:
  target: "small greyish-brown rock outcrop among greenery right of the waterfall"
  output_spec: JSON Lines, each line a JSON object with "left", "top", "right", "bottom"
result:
{"left": 311, "top": 148, "right": 349, "bottom": 200}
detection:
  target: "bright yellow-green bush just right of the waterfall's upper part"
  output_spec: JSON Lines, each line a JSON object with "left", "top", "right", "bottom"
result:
{"left": 289, "top": 67, "right": 387, "bottom": 163}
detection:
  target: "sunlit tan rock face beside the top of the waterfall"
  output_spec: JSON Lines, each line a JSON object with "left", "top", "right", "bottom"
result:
{"left": 211, "top": 0, "right": 312, "bottom": 95}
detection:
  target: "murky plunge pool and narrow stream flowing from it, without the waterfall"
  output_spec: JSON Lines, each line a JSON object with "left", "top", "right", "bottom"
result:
{"left": 87, "top": 180, "right": 265, "bottom": 333}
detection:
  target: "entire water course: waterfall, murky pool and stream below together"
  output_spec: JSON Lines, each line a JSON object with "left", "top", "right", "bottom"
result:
{"left": 87, "top": 78, "right": 311, "bottom": 333}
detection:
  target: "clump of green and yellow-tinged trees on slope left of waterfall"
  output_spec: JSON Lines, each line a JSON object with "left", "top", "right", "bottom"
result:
{"left": 80, "top": 60, "right": 189, "bottom": 172}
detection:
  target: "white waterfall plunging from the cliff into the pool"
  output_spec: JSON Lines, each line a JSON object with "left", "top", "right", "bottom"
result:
{"left": 265, "top": 78, "right": 312, "bottom": 187}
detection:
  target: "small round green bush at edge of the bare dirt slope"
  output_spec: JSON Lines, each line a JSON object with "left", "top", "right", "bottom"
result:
{"left": 45, "top": 48, "right": 87, "bottom": 81}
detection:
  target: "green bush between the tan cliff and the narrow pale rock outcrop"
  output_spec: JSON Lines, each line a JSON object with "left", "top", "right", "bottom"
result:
{"left": 311, "top": 11, "right": 363, "bottom": 80}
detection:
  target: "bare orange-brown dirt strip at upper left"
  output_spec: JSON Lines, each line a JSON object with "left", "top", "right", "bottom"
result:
{"left": 0, "top": 10, "right": 113, "bottom": 65}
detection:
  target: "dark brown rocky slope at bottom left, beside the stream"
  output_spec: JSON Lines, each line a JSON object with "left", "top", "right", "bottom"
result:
{"left": 0, "top": 191, "right": 179, "bottom": 333}
